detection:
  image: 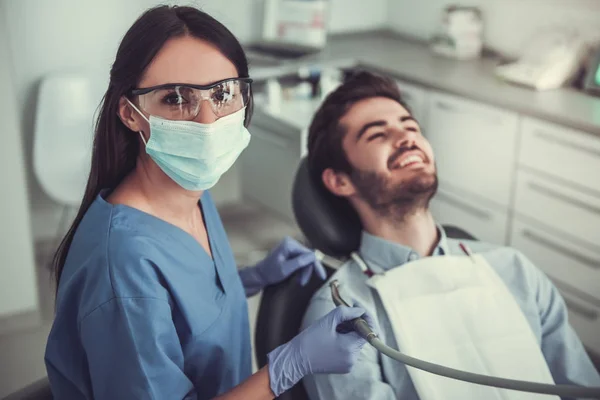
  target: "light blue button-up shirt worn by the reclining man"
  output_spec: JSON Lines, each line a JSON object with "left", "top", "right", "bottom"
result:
{"left": 303, "top": 227, "right": 600, "bottom": 400}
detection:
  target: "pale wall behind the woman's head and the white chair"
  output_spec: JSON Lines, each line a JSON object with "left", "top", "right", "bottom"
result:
{"left": 0, "top": 0, "right": 387, "bottom": 239}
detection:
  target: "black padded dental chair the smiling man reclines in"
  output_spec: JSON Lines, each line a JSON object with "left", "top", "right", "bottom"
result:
{"left": 254, "top": 158, "right": 476, "bottom": 400}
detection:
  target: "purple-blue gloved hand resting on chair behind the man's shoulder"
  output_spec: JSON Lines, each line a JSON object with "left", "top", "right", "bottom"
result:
{"left": 239, "top": 237, "right": 326, "bottom": 296}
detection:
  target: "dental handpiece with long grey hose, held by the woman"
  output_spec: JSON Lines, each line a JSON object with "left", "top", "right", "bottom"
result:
{"left": 329, "top": 280, "right": 600, "bottom": 399}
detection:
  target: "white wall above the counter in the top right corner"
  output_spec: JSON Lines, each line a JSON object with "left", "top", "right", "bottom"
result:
{"left": 388, "top": 0, "right": 600, "bottom": 56}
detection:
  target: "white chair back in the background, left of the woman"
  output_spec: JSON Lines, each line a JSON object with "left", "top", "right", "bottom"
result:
{"left": 33, "top": 71, "right": 108, "bottom": 262}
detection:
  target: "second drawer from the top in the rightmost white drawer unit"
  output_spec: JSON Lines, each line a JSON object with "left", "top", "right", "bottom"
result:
{"left": 515, "top": 171, "right": 600, "bottom": 245}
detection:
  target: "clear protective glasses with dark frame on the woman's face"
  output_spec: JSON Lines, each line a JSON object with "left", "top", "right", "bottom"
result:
{"left": 130, "top": 78, "right": 252, "bottom": 121}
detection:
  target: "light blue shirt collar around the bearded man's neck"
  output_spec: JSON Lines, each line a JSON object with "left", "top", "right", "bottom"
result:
{"left": 360, "top": 224, "right": 449, "bottom": 271}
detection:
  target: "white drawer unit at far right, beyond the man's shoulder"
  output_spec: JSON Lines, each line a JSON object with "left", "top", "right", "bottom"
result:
{"left": 510, "top": 118, "right": 600, "bottom": 354}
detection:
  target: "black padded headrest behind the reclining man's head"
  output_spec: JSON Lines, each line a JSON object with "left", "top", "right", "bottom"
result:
{"left": 292, "top": 157, "right": 362, "bottom": 257}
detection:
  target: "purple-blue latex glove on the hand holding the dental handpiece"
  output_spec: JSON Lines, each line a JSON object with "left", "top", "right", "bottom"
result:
{"left": 268, "top": 306, "right": 375, "bottom": 396}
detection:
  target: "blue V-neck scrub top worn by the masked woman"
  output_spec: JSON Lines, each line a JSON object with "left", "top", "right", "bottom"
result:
{"left": 46, "top": 191, "right": 251, "bottom": 400}
